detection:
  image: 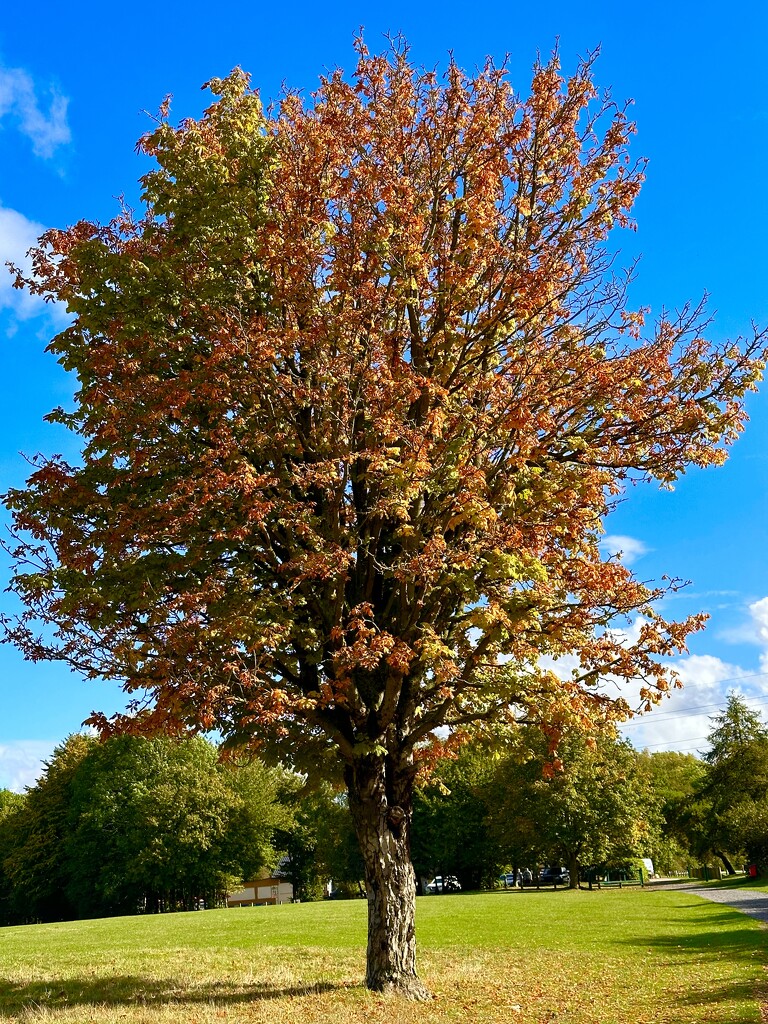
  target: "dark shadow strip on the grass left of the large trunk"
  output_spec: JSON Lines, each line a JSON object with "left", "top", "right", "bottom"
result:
{"left": 0, "top": 975, "right": 360, "bottom": 1017}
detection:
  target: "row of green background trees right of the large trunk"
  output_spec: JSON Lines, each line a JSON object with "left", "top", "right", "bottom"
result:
{"left": 413, "top": 694, "right": 768, "bottom": 888}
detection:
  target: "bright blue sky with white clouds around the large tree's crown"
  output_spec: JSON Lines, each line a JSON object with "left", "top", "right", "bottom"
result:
{"left": 0, "top": 0, "right": 768, "bottom": 788}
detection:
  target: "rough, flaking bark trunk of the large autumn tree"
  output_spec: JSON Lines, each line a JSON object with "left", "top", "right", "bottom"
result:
{"left": 344, "top": 755, "right": 430, "bottom": 999}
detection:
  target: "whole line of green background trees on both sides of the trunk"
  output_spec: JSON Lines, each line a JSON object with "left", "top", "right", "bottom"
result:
{"left": 0, "top": 694, "right": 768, "bottom": 924}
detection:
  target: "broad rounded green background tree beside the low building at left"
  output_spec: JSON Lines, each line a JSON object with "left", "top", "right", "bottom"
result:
{"left": 59, "top": 736, "right": 289, "bottom": 918}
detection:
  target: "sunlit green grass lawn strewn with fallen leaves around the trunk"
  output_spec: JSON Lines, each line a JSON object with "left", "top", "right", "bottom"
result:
{"left": 0, "top": 889, "right": 768, "bottom": 1024}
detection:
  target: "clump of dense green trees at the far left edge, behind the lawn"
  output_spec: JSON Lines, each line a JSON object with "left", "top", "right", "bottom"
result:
{"left": 0, "top": 734, "right": 290, "bottom": 924}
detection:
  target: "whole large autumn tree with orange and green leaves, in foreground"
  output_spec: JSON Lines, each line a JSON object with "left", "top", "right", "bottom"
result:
{"left": 6, "top": 43, "right": 764, "bottom": 997}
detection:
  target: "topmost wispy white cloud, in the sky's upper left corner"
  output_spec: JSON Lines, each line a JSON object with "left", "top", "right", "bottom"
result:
{"left": 0, "top": 68, "right": 72, "bottom": 159}
